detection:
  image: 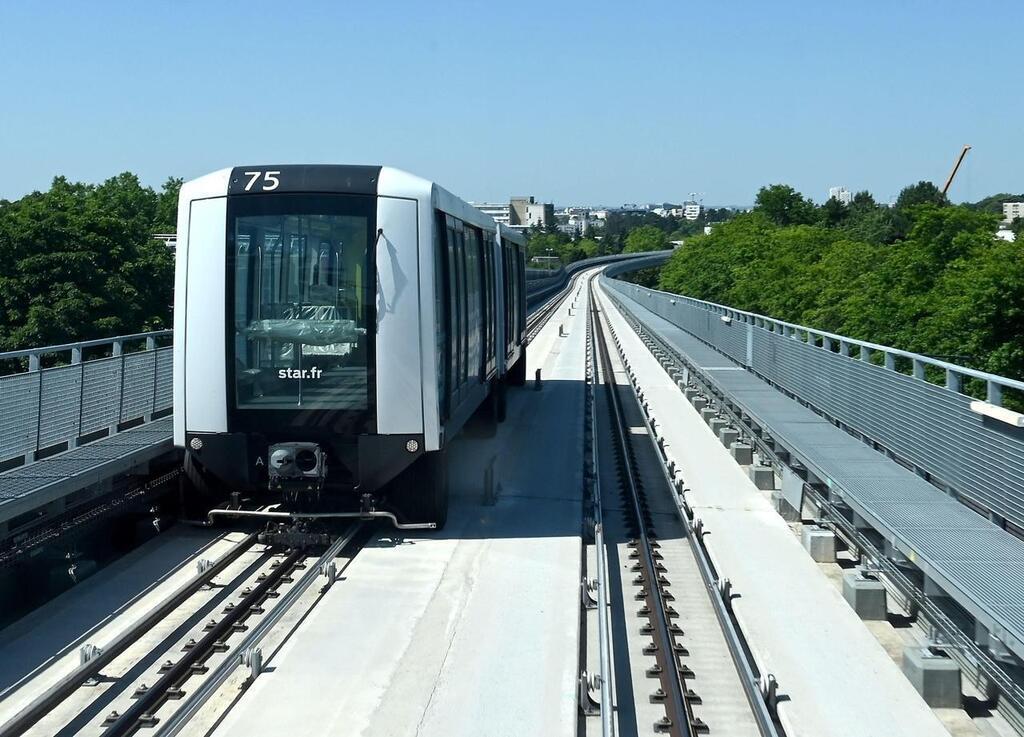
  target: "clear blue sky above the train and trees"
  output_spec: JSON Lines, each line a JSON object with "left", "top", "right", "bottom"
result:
{"left": 0, "top": 0, "right": 1024, "bottom": 205}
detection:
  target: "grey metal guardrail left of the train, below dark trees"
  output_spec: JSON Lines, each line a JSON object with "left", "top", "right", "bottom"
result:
{"left": 0, "top": 331, "right": 172, "bottom": 463}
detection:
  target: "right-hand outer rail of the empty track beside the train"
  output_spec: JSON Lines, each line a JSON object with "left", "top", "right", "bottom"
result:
{"left": 598, "top": 286, "right": 781, "bottom": 737}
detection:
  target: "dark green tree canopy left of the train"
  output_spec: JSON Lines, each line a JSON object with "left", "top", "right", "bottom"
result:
{"left": 0, "top": 172, "right": 181, "bottom": 350}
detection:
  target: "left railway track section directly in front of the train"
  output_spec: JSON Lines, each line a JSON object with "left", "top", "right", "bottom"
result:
{"left": 0, "top": 523, "right": 369, "bottom": 737}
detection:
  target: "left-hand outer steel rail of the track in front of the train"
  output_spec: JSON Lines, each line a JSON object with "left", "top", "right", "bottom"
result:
{"left": 0, "top": 534, "right": 256, "bottom": 737}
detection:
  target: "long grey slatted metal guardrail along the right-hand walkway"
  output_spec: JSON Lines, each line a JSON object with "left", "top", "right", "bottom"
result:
{"left": 603, "top": 255, "right": 1024, "bottom": 528}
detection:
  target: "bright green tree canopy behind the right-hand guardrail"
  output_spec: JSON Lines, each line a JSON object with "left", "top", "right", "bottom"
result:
{"left": 659, "top": 182, "right": 1024, "bottom": 391}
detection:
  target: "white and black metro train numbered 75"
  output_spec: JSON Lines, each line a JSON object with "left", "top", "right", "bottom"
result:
{"left": 174, "top": 165, "right": 526, "bottom": 527}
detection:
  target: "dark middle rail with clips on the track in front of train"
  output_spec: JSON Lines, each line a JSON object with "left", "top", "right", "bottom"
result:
{"left": 102, "top": 548, "right": 303, "bottom": 737}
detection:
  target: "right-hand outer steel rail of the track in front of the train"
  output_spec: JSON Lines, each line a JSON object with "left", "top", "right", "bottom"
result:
{"left": 157, "top": 522, "right": 362, "bottom": 737}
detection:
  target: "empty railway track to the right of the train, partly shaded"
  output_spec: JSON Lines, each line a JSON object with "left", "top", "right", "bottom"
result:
{"left": 581, "top": 281, "right": 779, "bottom": 737}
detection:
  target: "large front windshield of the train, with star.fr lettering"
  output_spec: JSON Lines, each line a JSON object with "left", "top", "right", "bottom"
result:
{"left": 227, "top": 194, "right": 376, "bottom": 414}
